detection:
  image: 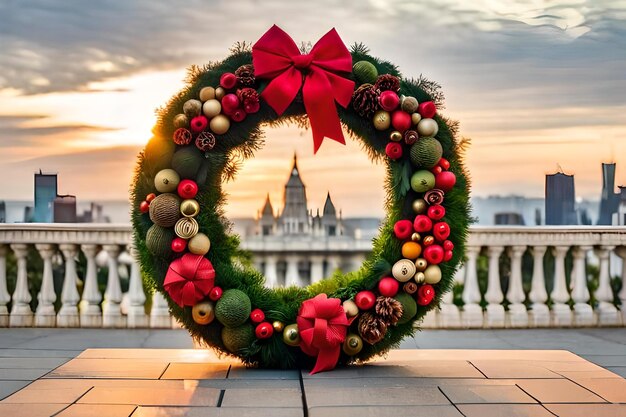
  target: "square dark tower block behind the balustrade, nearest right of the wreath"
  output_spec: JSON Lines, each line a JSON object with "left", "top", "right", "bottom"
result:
{"left": 545, "top": 172, "right": 578, "bottom": 225}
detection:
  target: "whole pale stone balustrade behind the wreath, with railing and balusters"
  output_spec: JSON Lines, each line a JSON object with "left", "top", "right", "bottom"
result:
{"left": 0, "top": 224, "right": 626, "bottom": 328}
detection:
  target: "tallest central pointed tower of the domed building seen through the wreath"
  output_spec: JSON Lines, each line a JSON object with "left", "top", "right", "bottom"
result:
{"left": 279, "top": 154, "right": 310, "bottom": 235}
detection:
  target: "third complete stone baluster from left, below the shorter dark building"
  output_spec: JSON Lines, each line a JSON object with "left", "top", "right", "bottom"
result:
{"left": 57, "top": 243, "right": 80, "bottom": 327}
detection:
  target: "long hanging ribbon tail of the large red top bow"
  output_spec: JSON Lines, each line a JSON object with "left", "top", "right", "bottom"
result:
{"left": 302, "top": 69, "right": 346, "bottom": 153}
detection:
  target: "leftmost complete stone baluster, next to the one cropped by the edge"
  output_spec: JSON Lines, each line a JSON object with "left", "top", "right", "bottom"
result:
{"left": 9, "top": 243, "right": 33, "bottom": 327}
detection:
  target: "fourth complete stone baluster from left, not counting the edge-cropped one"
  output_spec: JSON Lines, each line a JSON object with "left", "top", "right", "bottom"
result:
{"left": 80, "top": 244, "right": 102, "bottom": 327}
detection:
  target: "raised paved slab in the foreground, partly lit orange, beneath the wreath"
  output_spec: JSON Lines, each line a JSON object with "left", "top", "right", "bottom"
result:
{"left": 0, "top": 349, "right": 626, "bottom": 417}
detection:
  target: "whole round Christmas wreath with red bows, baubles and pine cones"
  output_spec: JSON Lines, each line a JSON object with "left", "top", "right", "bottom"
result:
{"left": 132, "top": 26, "right": 469, "bottom": 372}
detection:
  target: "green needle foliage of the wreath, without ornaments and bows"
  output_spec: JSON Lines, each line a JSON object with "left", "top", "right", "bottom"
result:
{"left": 131, "top": 44, "right": 470, "bottom": 368}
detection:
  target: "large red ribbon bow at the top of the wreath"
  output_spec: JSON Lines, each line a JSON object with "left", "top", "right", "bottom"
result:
{"left": 252, "top": 25, "right": 354, "bottom": 152}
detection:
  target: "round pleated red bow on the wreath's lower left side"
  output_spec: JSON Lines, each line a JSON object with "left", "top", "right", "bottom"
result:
{"left": 163, "top": 253, "right": 215, "bottom": 307}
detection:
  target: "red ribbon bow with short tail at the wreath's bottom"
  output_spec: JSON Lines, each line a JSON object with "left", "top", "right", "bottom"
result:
{"left": 296, "top": 294, "right": 350, "bottom": 375}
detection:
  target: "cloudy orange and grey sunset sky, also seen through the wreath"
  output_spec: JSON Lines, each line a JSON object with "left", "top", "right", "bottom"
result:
{"left": 0, "top": 0, "right": 626, "bottom": 216}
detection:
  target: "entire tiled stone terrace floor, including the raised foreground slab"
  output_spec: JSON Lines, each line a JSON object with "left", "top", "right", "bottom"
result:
{"left": 0, "top": 329, "right": 626, "bottom": 417}
